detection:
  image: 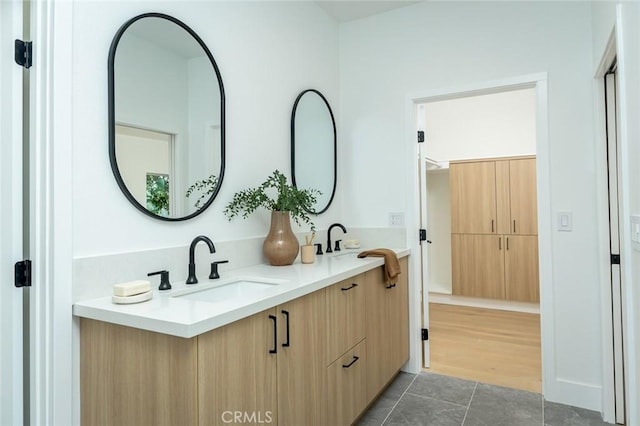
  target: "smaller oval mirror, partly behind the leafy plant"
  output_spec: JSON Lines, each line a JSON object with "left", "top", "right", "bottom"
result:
{"left": 291, "top": 89, "right": 336, "bottom": 214}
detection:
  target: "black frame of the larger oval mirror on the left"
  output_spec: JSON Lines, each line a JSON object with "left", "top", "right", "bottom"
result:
{"left": 108, "top": 12, "right": 225, "bottom": 222}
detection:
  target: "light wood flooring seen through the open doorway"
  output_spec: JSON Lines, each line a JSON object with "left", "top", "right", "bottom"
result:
{"left": 425, "top": 303, "right": 542, "bottom": 392}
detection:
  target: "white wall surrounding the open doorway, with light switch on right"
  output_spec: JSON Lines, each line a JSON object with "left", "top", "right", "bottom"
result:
{"left": 340, "top": 2, "right": 602, "bottom": 410}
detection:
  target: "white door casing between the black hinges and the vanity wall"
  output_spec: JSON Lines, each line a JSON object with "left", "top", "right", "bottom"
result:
{"left": 29, "top": 0, "right": 74, "bottom": 425}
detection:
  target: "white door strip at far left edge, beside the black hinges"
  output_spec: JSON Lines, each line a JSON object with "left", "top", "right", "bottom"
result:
{"left": 0, "top": 0, "right": 24, "bottom": 425}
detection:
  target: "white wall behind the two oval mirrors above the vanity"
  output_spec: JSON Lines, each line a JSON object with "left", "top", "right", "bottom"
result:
{"left": 71, "top": 1, "right": 344, "bottom": 257}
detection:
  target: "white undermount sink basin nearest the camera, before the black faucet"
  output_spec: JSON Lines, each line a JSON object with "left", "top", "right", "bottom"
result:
{"left": 173, "top": 278, "right": 282, "bottom": 303}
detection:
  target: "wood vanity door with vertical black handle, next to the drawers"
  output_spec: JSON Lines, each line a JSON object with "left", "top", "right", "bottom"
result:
{"left": 276, "top": 289, "right": 327, "bottom": 426}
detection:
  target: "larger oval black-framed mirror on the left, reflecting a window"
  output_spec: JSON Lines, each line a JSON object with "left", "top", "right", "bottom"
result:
{"left": 109, "top": 13, "right": 225, "bottom": 221}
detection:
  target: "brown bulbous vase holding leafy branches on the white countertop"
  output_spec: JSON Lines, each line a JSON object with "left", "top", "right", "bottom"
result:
{"left": 262, "top": 211, "right": 300, "bottom": 266}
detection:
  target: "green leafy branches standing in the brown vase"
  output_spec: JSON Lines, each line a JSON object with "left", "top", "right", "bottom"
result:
{"left": 224, "top": 170, "right": 321, "bottom": 231}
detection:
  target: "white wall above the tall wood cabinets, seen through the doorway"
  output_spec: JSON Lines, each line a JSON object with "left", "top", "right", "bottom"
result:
{"left": 424, "top": 89, "right": 536, "bottom": 161}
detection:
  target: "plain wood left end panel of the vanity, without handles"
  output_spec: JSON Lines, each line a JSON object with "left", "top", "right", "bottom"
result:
{"left": 80, "top": 318, "right": 198, "bottom": 426}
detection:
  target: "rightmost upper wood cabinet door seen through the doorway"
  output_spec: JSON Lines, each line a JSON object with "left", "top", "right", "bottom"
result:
{"left": 509, "top": 158, "right": 538, "bottom": 235}
